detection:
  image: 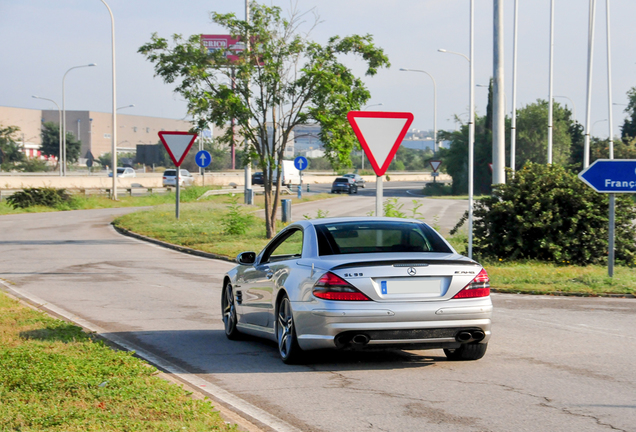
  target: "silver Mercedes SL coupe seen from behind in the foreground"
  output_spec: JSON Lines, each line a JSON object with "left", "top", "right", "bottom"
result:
{"left": 221, "top": 217, "right": 492, "bottom": 363}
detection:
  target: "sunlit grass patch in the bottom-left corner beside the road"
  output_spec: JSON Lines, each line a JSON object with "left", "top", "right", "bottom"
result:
{"left": 0, "top": 293, "right": 237, "bottom": 432}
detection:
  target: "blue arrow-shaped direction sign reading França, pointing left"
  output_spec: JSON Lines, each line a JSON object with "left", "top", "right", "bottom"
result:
{"left": 579, "top": 159, "right": 636, "bottom": 193}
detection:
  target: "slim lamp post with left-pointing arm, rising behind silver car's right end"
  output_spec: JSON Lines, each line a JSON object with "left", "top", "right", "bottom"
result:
{"left": 437, "top": 0, "right": 475, "bottom": 259}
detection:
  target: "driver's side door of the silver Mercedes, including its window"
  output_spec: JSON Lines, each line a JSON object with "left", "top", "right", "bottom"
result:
{"left": 241, "top": 228, "right": 303, "bottom": 327}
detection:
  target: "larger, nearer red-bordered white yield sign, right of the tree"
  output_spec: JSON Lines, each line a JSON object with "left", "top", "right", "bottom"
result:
{"left": 347, "top": 111, "right": 413, "bottom": 176}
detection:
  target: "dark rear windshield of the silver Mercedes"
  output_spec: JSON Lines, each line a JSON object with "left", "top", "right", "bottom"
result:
{"left": 316, "top": 221, "right": 452, "bottom": 255}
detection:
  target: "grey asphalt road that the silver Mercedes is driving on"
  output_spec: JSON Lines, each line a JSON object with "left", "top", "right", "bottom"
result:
{"left": 0, "top": 209, "right": 636, "bottom": 432}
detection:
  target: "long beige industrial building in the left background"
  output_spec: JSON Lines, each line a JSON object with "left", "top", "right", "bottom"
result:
{"left": 0, "top": 107, "right": 192, "bottom": 158}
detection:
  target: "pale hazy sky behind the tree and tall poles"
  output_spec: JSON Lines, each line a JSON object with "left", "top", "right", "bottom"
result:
{"left": 0, "top": 0, "right": 636, "bottom": 137}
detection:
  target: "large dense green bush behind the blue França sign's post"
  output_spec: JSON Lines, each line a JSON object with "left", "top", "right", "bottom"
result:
{"left": 455, "top": 163, "right": 636, "bottom": 265}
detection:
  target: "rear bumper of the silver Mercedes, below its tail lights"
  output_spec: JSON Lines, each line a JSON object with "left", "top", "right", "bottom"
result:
{"left": 292, "top": 297, "right": 492, "bottom": 350}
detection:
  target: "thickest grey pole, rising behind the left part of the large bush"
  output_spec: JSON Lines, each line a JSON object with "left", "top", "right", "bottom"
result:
{"left": 492, "top": 0, "right": 506, "bottom": 184}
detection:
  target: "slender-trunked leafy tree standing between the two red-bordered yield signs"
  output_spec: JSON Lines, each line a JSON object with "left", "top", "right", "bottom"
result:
{"left": 139, "top": 3, "right": 389, "bottom": 238}
